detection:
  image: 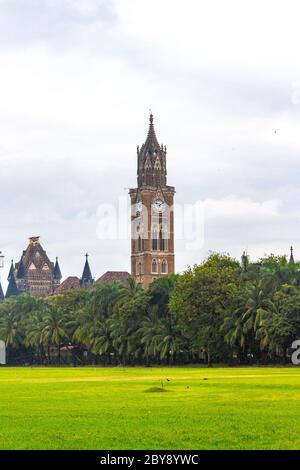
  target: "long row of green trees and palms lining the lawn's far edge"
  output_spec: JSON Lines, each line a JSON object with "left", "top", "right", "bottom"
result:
{"left": 0, "top": 254, "right": 300, "bottom": 365}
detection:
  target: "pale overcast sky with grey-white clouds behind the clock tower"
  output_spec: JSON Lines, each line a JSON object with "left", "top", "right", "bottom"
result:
{"left": 0, "top": 0, "right": 300, "bottom": 286}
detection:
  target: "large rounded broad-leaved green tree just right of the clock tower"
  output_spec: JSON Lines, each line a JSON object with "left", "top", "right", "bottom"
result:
{"left": 170, "top": 254, "right": 241, "bottom": 364}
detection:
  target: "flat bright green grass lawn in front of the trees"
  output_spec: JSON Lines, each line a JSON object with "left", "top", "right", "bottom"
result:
{"left": 0, "top": 367, "right": 300, "bottom": 450}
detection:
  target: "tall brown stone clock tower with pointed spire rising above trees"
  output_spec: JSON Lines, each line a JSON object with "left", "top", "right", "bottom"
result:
{"left": 129, "top": 114, "right": 175, "bottom": 287}
